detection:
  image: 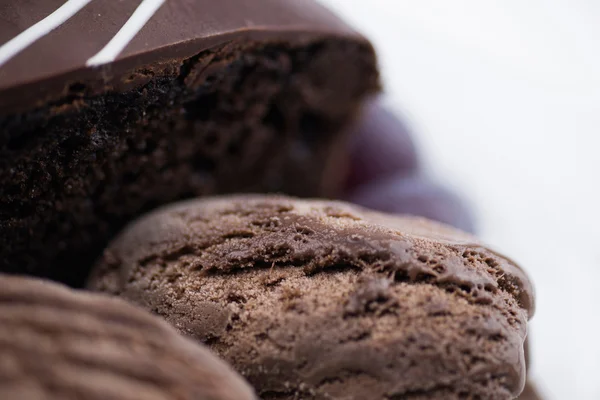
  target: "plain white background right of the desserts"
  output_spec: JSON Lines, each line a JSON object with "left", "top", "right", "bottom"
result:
{"left": 322, "top": 0, "right": 600, "bottom": 400}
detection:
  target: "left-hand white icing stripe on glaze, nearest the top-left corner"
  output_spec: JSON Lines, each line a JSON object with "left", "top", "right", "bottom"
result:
{"left": 0, "top": 0, "right": 92, "bottom": 66}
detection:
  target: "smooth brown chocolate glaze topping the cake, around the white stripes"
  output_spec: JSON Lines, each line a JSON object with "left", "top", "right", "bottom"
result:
{"left": 0, "top": 0, "right": 360, "bottom": 114}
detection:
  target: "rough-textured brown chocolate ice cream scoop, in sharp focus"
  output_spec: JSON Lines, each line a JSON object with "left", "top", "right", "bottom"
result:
{"left": 89, "top": 195, "right": 533, "bottom": 400}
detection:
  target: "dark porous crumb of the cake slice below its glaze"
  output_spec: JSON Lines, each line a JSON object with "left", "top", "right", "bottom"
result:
{"left": 0, "top": 35, "right": 378, "bottom": 285}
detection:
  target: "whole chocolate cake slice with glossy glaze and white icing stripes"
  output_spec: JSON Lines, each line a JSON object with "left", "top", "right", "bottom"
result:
{"left": 0, "top": 0, "right": 378, "bottom": 284}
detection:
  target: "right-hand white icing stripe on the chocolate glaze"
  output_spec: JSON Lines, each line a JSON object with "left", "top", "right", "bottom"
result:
{"left": 85, "top": 0, "right": 166, "bottom": 66}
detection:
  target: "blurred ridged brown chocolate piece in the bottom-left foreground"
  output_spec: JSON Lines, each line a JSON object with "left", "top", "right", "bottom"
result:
{"left": 0, "top": 275, "right": 255, "bottom": 400}
